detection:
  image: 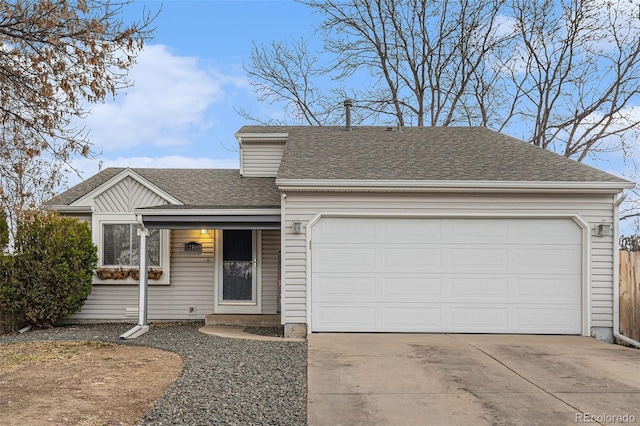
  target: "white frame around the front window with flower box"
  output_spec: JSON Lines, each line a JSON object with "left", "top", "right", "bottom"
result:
{"left": 92, "top": 213, "right": 171, "bottom": 285}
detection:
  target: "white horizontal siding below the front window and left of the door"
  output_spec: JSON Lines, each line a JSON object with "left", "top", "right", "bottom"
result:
{"left": 72, "top": 230, "right": 214, "bottom": 322}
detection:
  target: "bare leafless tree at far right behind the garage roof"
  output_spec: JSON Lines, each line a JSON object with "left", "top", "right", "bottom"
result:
{"left": 500, "top": 0, "right": 640, "bottom": 161}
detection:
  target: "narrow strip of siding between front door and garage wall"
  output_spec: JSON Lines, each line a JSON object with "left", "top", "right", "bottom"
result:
{"left": 262, "top": 230, "right": 280, "bottom": 314}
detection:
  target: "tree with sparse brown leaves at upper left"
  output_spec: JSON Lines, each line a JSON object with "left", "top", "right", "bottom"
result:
{"left": 0, "top": 0, "right": 155, "bottom": 233}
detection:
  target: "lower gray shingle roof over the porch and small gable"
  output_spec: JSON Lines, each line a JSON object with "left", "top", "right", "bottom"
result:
{"left": 48, "top": 168, "right": 280, "bottom": 209}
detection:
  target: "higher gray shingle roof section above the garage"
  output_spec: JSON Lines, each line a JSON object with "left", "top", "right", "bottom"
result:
{"left": 238, "top": 126, "right": 626, "bottom": 183}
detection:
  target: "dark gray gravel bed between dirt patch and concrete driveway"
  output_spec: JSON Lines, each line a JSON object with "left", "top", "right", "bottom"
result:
{"left": 0, "top": 322, "right": 307, "bottom": 425}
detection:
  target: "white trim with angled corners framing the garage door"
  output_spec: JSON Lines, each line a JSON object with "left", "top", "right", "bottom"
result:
{"left": 306, "top": 212, "right": 591, "bottom": 336}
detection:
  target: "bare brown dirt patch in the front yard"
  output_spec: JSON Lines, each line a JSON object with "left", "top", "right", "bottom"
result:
{"left": 0, "top": 341, "right": 182, "bottom": 425}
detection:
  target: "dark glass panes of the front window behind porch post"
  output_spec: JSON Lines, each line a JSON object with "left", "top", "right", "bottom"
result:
{"left": 102, "top": 223, "right": 161, "bottom": 268}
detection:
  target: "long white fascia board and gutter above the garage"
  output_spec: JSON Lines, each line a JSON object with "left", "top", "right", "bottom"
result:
{"left": 276, "top": 179, "right": 635, "bottom": 193}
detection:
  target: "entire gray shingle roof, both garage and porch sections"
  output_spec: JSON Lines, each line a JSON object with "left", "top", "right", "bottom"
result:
{"left": 47, "top": 126, "right": 627, "bottom": 209}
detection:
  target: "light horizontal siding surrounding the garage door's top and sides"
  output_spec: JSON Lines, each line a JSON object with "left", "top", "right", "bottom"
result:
{"left": 282, "top": 191, "right": 614, "bottom": 327}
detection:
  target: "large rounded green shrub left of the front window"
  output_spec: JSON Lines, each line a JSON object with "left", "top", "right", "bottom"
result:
{"left": 12, "top": 212, "right": 98, "bottom": 327}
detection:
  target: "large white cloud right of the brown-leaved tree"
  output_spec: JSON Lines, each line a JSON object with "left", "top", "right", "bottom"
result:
{"left": 83, "top": 45, "right": 246, "bottom": 152}
